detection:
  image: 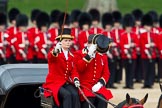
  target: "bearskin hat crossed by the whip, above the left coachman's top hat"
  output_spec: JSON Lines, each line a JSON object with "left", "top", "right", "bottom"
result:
{"left": 58, "top": 12, "right": 70, "bottom": 28}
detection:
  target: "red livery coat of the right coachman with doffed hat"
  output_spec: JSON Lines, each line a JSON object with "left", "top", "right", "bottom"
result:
{"left": 75, "top": 49, "right": 113, "bottom": 100}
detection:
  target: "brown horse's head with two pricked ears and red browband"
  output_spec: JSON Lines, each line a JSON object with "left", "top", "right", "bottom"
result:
{"left": 115, "top": 93, "right": 148, "bottom": 108}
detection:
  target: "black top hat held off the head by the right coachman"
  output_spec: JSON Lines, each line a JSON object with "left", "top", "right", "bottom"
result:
{"left": 92, "top": 34, "right": 112, "bottom": 53}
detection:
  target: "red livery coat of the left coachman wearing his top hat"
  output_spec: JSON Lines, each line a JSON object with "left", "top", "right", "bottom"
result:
{"left": 43, "top": 51, "right": 78, "bottom": 105}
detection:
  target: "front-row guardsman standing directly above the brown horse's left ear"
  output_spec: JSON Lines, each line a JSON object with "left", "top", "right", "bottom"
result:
{"left": 120, "top": 14, "right": 139, "bottom": 89}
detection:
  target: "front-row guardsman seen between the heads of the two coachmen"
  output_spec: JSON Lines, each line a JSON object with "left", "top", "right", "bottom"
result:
{"left": 78, "top": 12, "right": 92, "bottom": 50}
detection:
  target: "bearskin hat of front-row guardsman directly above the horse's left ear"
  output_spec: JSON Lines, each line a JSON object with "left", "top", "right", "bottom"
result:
{"left": 123, "top": 14, "right": 135, "bottom": 28}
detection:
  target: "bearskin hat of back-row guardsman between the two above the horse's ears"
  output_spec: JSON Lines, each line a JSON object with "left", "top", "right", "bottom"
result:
{"left": 132, "top": 9, "right": 143, "bottom": 21}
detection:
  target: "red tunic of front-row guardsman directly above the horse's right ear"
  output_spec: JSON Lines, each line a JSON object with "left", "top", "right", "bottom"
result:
{"left": 140, "top": 32, "right": 158, "bottom": 59}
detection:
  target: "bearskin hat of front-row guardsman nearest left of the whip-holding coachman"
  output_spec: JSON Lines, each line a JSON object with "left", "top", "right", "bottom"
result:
{"left": 36, "top": 12, "right": 50, "bottom": 29}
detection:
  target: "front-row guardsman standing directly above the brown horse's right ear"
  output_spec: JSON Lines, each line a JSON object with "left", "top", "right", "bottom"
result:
{"left": 140, "top": 14, "right": 157, "bottom": 88}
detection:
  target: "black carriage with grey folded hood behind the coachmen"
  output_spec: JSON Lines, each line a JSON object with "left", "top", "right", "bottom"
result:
{"left": 0, "top": 64, "right": 48, "bottom": 108}
